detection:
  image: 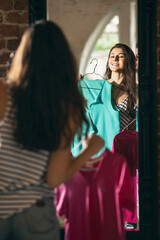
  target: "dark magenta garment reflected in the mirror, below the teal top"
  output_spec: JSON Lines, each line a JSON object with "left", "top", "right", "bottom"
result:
{"left": 112, "top": 129, "right": 138, "bottom": 223}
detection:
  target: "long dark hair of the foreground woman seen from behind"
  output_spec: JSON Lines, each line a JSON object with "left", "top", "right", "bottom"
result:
{"left": 8, "top": 20, "right": 88, "bottom": 151}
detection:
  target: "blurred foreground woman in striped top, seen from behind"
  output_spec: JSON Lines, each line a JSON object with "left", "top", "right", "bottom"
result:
{"left": 0, "top": 21, "right": 104, "bottom": 240}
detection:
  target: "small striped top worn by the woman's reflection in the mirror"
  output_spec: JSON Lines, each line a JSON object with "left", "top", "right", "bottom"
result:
{"left": 117, "top": 97, "right": 131, "bottom": 130}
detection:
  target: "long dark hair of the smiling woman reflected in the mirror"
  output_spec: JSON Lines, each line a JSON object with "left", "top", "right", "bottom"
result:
{"left": 105, "top": 43, "right": 136, "bottom": 118}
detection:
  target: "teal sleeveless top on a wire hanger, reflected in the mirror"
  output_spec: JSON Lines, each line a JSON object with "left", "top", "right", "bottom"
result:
{"left": 72, "top": 78, "right": 120, "bottom": 157}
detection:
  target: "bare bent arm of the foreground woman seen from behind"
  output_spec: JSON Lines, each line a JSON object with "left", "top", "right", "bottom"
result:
{"left": 47, "top": 108, "right": 104, "bottom": 188}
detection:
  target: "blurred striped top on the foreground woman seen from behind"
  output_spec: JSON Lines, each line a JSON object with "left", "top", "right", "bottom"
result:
{"left": 0, "top": 91, "right": 53, "bottom": 218}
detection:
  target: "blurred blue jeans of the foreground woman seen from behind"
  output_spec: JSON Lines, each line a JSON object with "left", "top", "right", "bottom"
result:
{"left": 0, "top": 199, "right": 60, "bottom": 240}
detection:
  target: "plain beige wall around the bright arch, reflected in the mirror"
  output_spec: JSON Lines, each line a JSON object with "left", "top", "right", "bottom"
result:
{"left": 47, "top": 0, "right": 137, "bottom": 63}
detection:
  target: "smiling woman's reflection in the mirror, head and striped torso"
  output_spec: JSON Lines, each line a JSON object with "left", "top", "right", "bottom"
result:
{"left": 105, "top": 43, "right": 136, "bottom": 130}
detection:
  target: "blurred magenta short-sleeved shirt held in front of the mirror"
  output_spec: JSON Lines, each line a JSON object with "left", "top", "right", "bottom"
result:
{"left": 54, "top": 149, "right": 134, "bottom": 240}
